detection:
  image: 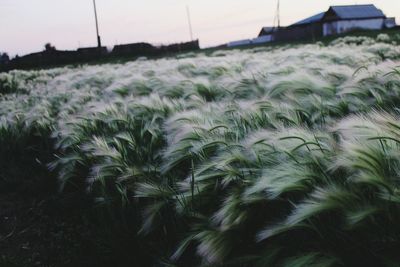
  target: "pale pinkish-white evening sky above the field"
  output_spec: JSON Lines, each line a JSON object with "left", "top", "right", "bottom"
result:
{"left": 0, "top": 0, "right": 400, "bottom": 56}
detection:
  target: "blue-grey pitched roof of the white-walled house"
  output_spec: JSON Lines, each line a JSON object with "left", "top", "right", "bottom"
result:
{"left": 328, "top": 5, "right": 385, "bottom": 19}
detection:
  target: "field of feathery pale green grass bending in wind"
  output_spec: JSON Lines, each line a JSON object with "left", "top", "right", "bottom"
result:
{"left": 0, "top": 34, "right": 400, "bottom": 267}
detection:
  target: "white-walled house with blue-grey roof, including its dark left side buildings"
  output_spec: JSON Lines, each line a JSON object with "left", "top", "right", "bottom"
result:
{"left": 259, "top": 5, "right": 396, "bottom": 41}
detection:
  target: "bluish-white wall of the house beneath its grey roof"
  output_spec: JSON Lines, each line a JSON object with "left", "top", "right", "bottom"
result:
{"left": 323, "top": 18, "right": 385, "bottom": 36}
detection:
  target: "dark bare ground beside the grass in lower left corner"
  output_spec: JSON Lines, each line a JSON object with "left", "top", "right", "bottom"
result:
{"left": 0, "top": 193, "right": 109, "bottom": 267}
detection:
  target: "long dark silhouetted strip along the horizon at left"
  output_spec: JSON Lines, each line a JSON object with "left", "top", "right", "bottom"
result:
{"left": 0, "top": 40, "right": 200, "bottom": 71}
